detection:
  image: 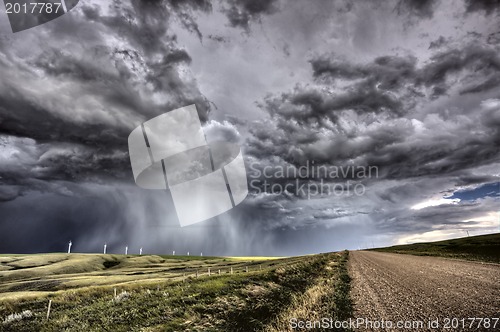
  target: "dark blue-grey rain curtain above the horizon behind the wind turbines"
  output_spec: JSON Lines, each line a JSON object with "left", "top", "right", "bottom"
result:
{"left": 0, "top": 187, "right": 356, "bottom": 255}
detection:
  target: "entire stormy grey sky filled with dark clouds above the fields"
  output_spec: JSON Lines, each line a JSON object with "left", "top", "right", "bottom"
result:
{"left": 0, "top": 0, "right": 500, "bottom": 256}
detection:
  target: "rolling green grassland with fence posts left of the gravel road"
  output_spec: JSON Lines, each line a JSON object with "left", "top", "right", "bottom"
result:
{"left": 0, "top": 253, "right": 351, "bottom": 332}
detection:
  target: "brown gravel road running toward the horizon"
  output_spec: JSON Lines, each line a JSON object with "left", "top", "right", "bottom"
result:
{"left": 349, "top": 251, "right": 500, "bottom": 331}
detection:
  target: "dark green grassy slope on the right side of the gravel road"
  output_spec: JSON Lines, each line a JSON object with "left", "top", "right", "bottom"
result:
{"left": 371, "top": 233, "right": 500, "bottom": 263}
